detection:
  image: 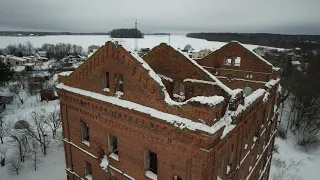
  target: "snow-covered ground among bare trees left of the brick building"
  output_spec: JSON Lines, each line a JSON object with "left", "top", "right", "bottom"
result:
{"left": 0, "top": 85, "right": 66, "bottom": 180}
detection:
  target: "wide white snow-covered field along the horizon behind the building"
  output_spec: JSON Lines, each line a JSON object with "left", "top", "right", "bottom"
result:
{"left": 0, "top": 35, "right": 282, "bottom": 50}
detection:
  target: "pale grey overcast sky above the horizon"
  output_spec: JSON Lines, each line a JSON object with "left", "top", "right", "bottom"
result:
{"left": 0, "top": 0, "right": 320, "bottom": 34}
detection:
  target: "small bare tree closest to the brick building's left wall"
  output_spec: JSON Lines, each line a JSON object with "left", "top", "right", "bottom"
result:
{"left": 45, "top": 110, "right": 62, "bottom": 139}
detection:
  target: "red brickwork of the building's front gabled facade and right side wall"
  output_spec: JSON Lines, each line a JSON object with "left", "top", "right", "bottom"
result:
{"left": 59, "top": 41, "right": 278, "bottom": 180}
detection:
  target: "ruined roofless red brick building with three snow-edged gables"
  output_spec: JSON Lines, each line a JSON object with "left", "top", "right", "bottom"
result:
{"left": 57, "top": 41, "right": 280, "bottom": 180}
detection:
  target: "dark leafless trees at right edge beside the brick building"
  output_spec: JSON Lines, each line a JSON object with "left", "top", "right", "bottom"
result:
{"left": 278, "top": 55, "right": 320, "bottom": 150}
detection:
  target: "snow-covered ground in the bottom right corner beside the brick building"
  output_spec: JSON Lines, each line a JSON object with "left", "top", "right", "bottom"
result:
{"left": 270, "top": 100, "right": 320, "bottom": 180}
